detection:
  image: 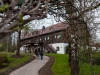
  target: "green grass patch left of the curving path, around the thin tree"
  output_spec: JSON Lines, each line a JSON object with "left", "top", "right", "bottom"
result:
{"left": 0, "top": 53, "right": 30, "bottom": 73}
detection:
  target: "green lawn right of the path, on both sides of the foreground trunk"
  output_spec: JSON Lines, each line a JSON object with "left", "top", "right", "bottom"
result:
{"left": 47, "top": 54, "right": 100, "bottom": 75}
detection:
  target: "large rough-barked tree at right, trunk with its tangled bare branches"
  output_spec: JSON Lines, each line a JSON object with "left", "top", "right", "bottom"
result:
{"left": 48, "top": 0, "right": 100, "bottom": 75}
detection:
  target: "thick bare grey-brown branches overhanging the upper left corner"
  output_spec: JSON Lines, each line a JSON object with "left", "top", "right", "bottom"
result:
{"left": 0, "top": 0, "right": 47, "bottom": 41}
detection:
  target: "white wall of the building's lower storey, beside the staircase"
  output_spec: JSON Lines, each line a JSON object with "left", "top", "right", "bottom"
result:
{"left": 50, "top": 43, "right": 68, "bottom": 54}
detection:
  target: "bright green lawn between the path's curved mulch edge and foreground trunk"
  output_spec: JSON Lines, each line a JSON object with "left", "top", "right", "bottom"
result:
{"left": 48, "top": 54, "right": 70, "bottom": 75}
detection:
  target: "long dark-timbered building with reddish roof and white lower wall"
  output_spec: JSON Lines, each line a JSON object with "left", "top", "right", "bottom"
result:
{"left": 20, "top": 23, "right": 69, "bottom": 54}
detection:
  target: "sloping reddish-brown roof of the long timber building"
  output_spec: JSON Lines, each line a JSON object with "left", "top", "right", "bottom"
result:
{"left": 23, "top": 23, "right": 69, "bottom": 39}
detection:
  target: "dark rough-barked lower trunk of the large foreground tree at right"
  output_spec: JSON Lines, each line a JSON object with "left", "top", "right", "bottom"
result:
{"left": 70, "top": 35, "right": 79, "bottom": 75}
